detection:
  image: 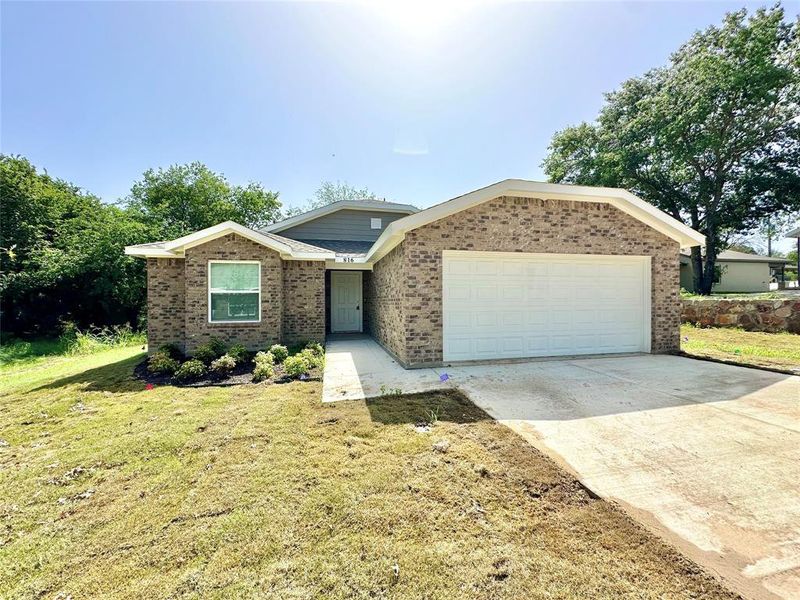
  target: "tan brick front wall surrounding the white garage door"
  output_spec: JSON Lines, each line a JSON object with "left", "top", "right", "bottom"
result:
{"left": 373, "top": 198, "right": 681, "bottom": 365}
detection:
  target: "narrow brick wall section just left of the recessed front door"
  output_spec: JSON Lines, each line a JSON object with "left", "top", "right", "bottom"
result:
{"left": 283, "top": 260, "right": 325, "bottom": 344}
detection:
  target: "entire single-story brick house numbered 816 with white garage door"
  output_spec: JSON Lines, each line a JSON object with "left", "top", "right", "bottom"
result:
{"left": 126, "top": 179, "right": 704, "bottom": 367}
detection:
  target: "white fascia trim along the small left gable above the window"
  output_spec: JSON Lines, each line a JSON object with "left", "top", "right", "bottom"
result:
{"left": 125, "top": 221, "right": 336, "bottom": 260}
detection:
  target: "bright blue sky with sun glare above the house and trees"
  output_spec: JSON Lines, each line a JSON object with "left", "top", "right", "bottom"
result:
{"left": 0, "top": 0, "right": 800, "bottom": 233}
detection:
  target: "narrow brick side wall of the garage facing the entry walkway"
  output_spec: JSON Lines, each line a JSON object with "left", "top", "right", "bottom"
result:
{"left": 364, "top": 243, "right": 408, "bottom": 362}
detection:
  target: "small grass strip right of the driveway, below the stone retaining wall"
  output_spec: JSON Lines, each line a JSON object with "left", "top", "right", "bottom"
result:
{"left": 681, "top": 324, "right": 800, "bottom": 373}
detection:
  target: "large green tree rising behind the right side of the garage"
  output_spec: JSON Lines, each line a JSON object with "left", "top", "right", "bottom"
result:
{"left": 543, "top": 6, "right": 800, "bottom": 294}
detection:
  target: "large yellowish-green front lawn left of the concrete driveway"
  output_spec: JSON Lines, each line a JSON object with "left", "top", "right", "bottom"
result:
{"left": 0, "top": 348, "right": 733, "bottom": 599}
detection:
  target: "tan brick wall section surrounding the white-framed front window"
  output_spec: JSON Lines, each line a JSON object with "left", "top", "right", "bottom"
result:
{"left": 185, "top": 234, "right": 283, "bottom": 353}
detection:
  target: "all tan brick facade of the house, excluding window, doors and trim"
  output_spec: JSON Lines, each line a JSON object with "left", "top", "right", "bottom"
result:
{"left": 148, "top": 197, "right": 681, "bottom": 366}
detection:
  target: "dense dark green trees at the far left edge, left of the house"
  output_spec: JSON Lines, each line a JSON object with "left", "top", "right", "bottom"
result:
{"left": 0, "top": 156, "right": 150, "bottom": 333}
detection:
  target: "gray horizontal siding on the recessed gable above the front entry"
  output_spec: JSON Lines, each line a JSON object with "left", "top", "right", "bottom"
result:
{"left": 278, "top": 209, "right": 408, "bottom": 242}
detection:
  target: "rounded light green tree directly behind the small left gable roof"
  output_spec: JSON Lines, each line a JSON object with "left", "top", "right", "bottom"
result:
{"left": 127, "top": 162, "right": 281, "bottom": 239}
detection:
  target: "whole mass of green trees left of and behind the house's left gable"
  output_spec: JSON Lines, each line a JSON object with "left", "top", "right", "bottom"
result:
{"left": 0, "top": 155, "right": 280, "bottom": 334}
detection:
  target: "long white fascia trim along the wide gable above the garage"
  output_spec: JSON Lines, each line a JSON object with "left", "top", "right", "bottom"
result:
{"left": 366, "top": 179, "right": 705, "bottom": 261}
